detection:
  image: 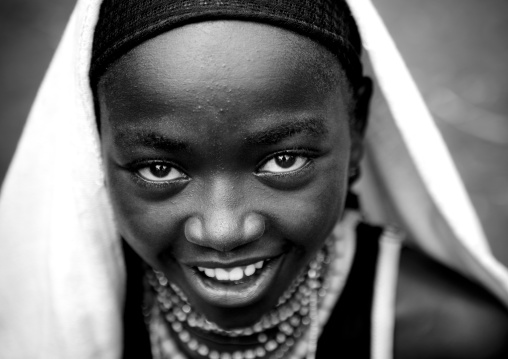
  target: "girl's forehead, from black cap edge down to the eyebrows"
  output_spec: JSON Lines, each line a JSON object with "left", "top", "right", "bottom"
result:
{"left": 99, "top": 21, "right": 349, "bottom": 148}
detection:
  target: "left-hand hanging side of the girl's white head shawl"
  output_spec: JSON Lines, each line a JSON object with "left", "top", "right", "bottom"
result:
{"left": 0, "top": 1, "right": 125, "bottom": 359}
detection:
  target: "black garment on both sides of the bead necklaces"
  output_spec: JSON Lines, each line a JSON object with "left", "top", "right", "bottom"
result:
{"left": 123, "top": 223, "right": 382, "bottom": 359}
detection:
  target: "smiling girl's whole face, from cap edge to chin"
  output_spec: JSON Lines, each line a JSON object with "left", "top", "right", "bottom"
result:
{"left": 99, "top": 21, "right": 360, "bottom": 328}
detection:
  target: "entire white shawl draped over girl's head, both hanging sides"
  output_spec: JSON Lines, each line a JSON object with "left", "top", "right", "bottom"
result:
{"left": 0, "top": 0, "right": 508, "bottom": 359}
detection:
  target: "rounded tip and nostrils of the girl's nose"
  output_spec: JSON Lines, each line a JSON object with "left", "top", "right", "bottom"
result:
{"left": 185, "top": 209, "right": 265, "bottom": 252}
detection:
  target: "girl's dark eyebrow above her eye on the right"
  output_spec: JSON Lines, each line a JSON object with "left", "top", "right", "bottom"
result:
{"left": 245, "top": 118, "right": 328, "bottom": 146}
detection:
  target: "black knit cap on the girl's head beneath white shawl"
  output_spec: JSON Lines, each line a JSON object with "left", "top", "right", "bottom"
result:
{"left": 90, "top": 0, "right": 362, "bottom": 90}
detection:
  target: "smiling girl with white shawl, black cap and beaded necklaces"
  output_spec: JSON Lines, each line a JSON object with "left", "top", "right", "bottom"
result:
{"left": 0, "top": 0, "right": 508, "bottom": 359}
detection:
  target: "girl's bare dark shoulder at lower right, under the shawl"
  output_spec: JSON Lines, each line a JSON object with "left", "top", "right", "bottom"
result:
{"left": 394, "top": 248, "right": 508, "bottom": 359}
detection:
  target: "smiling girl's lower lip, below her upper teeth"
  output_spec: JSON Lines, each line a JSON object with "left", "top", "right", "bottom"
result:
{"left": 181, "top": 255, "right": 284, "bottom": 308}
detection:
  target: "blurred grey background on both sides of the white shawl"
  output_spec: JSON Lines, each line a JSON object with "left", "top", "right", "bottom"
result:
{"left": 0, "top": 0, "right": 508, "bottom": 265}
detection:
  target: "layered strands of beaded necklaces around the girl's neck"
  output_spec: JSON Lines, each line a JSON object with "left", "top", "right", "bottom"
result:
{"left": 144, "top": 212, "right": 359, "bottom": 359}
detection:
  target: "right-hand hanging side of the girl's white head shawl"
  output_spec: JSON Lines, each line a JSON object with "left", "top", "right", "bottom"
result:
{"left": 348, "top": 0, "right": 508, "bottom": 305}
